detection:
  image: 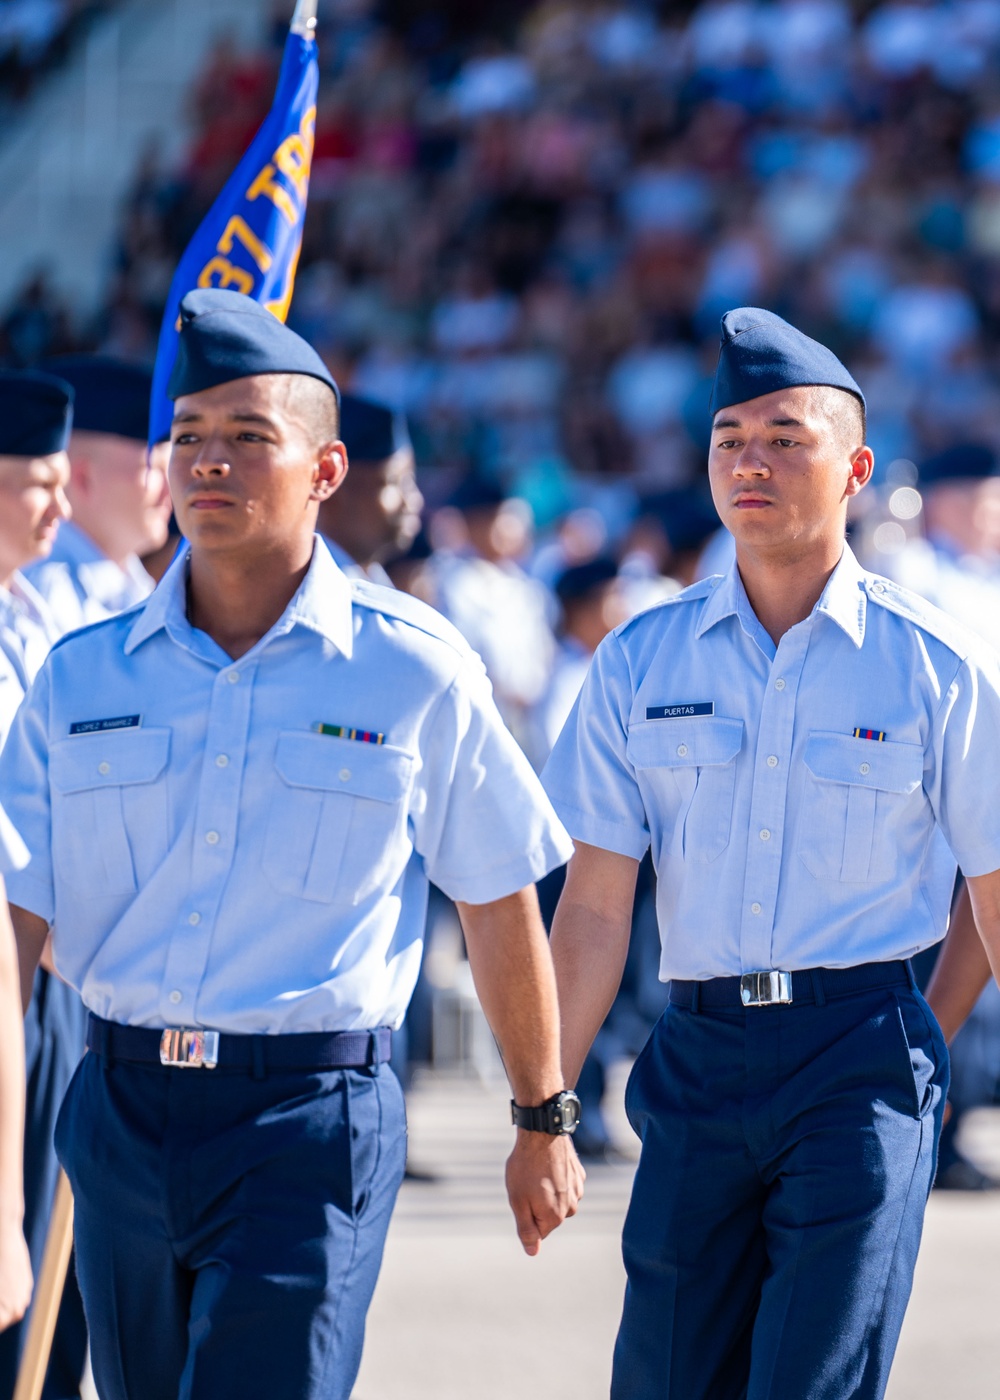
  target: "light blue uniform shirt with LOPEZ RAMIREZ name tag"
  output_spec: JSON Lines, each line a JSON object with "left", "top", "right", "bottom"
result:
{"left": 0, "top": 546, "right": 571, "bottom": 1033}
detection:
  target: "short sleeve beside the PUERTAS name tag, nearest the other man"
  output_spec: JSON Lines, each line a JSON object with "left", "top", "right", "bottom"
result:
{"left": 542, "top": 633, "right": 650, "bottom": 860}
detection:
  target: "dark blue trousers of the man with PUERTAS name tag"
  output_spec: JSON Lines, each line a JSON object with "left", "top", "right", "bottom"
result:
{"left": 612, "top": 987, "right": 948, "bottom": 1400}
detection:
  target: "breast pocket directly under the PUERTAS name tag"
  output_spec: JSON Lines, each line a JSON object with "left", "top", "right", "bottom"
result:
{"left": 627, "top": 715, "right": 744, "bottom": 862}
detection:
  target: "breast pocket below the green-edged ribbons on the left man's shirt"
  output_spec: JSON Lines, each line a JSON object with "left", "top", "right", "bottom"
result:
{"left": 263, "top": 734, "right": 413, "bottom": 904}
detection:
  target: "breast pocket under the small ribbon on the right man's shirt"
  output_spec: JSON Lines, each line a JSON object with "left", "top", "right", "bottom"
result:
{"left": 798, "top": 734, "right": 923, "bottom": 885}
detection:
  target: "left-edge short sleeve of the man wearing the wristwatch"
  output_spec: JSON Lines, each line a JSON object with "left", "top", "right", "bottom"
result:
{"left": 0, "top": 666, "right": 55, "bottom": 924}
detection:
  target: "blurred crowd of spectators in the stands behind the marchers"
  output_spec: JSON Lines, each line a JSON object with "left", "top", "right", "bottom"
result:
{"left": 0, "top": 0, "right": 1000, "bottom": 512}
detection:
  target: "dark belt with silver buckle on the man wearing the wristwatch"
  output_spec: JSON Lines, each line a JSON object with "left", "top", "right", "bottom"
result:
{"left": 87, "top": 1011, "right": 392, "bottom": 1075}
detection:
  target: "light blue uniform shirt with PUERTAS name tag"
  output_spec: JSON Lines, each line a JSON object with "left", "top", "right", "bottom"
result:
{"left": 542, "top": 547, "right": 1000, "bottom": 980}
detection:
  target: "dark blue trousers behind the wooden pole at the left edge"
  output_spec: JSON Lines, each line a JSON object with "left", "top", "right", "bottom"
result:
{"left": 0, "top": 967, "right": 87, "bottom": 1400}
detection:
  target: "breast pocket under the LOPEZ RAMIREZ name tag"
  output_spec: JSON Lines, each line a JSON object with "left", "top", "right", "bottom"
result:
{"left": 49, "top": 729, "right": 171, "bottom": 899}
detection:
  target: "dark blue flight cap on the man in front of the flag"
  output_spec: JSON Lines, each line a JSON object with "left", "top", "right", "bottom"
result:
{"left": 167, "top": 287, "right": 340, "bottom": 405}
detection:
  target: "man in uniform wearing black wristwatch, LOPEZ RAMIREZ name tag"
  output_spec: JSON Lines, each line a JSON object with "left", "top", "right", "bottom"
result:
{"left": 0, "top": 288, "right": 583, "bottom": 1400}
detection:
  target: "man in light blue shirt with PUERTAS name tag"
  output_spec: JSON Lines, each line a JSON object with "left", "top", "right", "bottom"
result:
{"left": 543, "top": 307, "right": 1000, "bottom": 1400}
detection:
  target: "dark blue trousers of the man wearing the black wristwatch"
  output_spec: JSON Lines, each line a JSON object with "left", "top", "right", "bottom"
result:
{"left": 56, "top": 1053, "right": 406, "bottom": 1400}
